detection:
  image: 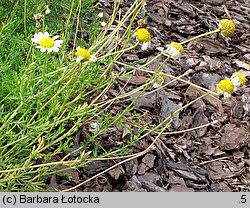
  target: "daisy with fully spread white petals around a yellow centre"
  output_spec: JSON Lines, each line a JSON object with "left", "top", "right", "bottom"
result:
{"left": 31, "top": 32, "right": 63, "bottom": 52}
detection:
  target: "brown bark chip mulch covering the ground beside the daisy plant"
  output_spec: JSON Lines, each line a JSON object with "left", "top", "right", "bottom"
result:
{"left": 47, "top": 0, "right": 250, "bottom": 192}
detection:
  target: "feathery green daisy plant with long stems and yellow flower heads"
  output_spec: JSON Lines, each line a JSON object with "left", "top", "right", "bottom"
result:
{"left": 0, "top": 0, "right": 249, "bottom": 191}
